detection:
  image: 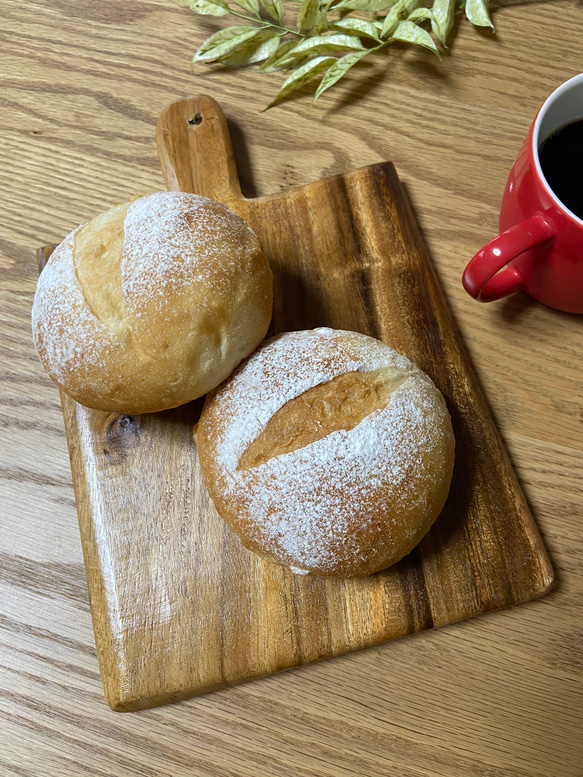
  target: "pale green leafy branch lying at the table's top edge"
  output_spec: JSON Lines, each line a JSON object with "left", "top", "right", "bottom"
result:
{"left": 177, "top": 0, "right": 494, "bottom": 108}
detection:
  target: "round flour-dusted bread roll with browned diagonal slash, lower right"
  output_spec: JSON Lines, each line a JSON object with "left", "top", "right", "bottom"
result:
{"left": 197, "top": 329, "right": 454, "bottom": 577}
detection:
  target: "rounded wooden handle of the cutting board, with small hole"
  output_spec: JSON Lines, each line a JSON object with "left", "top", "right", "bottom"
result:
{"left": 156, "top": 95, "right": 243, "bottom": 205}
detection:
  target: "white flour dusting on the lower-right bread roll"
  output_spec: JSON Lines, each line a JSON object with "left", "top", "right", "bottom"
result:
{"left": 210, "top": 329, "right": 447, "bottom": 568}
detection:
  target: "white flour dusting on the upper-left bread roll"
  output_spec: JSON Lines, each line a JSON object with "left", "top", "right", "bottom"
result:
{"left": 32, "top": 192, "right": 258, "bottom": 390}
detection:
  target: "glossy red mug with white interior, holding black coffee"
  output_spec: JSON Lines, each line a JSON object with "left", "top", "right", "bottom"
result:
{"left": 462, "top": 73, "right": 583, "bottom": 313}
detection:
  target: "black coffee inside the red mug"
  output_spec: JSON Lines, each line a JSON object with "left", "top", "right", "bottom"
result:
{"left": 539, "top": 119, "right": 583, "bottom": 219}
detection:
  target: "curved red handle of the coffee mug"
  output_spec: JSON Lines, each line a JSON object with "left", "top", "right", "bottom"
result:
{"left": 462, "top": 213, "right": 553, "bottom": 302}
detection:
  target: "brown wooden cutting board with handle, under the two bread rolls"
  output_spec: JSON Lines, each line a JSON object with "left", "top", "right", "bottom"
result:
{"left": 39, "top": 97, "right": 553, "bottom": 710}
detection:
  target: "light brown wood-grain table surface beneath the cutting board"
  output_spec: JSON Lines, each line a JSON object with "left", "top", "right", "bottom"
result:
{"left": 0, "top": 0, "right": 583, "bottom": 777}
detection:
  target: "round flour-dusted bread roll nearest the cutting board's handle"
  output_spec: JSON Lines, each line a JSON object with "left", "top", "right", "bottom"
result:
{"left": 32, "top": 192, "right": 272, "bottom": 413}
